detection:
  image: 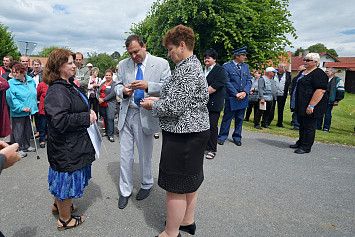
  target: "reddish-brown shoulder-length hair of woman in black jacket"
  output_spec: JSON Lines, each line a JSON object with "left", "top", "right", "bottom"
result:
{"left": 42, "top": 49, "right": 75, "bottom": 85}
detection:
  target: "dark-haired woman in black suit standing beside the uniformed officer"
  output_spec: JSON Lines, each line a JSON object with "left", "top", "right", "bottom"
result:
{"left": 203, "top": 49, "right": 227, "bottom": 159}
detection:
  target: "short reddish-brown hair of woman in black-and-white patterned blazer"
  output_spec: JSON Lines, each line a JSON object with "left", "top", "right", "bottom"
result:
{"left": 163, "top": 25, "right": 195, "bottom": 50}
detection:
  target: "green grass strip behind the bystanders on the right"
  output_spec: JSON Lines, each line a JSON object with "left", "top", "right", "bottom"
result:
{"left": 219, "top": 93, "right": 355, "bottom": 146}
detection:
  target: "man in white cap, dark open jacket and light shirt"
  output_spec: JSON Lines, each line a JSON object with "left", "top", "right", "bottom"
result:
{"left": 268, "top": 63, "right": 291, "bottom": 128}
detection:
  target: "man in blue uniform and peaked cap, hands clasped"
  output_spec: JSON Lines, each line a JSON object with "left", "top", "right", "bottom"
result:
{"left": 218, "top": 46, "right": 251, "bottom": 146}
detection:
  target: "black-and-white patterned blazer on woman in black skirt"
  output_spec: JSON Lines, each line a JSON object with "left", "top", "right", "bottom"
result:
{"left": 152, "top": 55, "right": 210, "bottom": 133}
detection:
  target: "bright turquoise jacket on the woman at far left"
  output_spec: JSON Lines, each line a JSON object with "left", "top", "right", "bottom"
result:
{"left": 6, "top": 75, "right": 38, "bottom": 117}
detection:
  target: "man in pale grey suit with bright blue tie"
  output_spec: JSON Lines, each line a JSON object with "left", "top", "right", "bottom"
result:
{"left": 115, "top": 35, "right": 170, "bottom": 209}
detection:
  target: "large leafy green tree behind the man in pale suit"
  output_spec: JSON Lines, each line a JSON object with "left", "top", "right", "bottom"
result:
{"left": 131, "top": 0, "right": 297, "bottom": 68}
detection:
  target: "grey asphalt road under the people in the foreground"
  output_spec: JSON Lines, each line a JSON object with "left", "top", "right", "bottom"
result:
{"left": 0, "top": 128, "right": 355, "bottom": 237}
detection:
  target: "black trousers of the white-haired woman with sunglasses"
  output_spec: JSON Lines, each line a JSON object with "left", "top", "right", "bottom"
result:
{"left": 296, "top": 115, "right": 318, "bottom": 152}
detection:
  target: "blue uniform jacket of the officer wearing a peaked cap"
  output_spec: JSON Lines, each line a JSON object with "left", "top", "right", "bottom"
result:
{"left": 223, "top": 61, "right": 251, "bottom": 100}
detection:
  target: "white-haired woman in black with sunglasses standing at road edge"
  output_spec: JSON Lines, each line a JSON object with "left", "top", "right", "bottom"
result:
{"left": 290, "top": 53, "right": 328, "bottom": 154}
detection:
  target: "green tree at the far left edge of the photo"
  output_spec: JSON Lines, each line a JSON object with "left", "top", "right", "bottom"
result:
{"left": 0, "top": 23, "right": 21, "bottom": 60}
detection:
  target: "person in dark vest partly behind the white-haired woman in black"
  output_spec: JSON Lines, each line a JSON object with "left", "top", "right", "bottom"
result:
{"left": 317, "top": 68, "right": 345, "bottom": 132}
